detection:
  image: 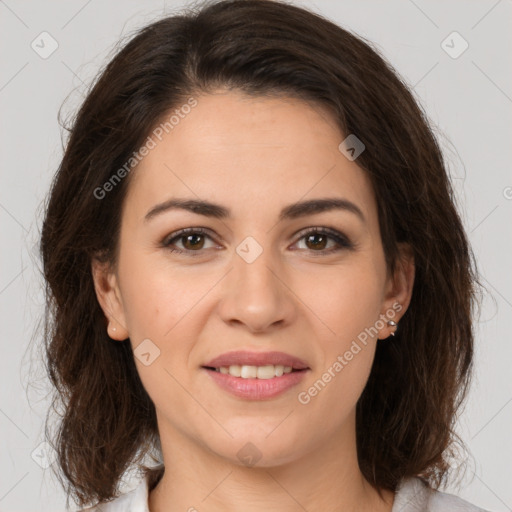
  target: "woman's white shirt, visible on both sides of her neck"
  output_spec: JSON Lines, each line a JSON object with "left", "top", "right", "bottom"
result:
{"left": 79, "top": 477, "right": 489, "bottom": 512}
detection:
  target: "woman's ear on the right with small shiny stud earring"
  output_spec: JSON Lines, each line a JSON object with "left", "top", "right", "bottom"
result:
{"left": 378, "top": 243, "right": 415, "bottom": 339}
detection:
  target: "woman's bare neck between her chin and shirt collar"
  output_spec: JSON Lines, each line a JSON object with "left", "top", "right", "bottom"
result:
{"left": 148, "top": 412, "right": 394, "bottom": 512}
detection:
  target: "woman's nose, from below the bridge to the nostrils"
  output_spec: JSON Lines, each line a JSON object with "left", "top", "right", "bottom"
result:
{"left": 219, "top": 242, "right": 296, "bottom": 333}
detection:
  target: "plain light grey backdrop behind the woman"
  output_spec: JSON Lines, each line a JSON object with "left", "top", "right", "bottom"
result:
{"left": 0, "top": 0, "right": 512, "bottom": 512}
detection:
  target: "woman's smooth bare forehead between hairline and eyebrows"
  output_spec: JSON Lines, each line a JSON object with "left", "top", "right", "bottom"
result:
{"left": 122, "top": 91, "right": 375, "bottom": 226}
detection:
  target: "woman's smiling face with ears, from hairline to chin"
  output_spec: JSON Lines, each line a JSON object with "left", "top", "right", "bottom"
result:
{"left": 93, "top": 91, "right": 413, "bottom": 466}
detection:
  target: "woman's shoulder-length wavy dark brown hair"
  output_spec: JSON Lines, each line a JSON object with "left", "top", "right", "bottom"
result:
{"left": 41, "top": 0, "right": 477, "bottom": 505}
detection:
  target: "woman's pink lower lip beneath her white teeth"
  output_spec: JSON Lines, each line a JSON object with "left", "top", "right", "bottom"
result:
{"left": 204, "top": 369, "right": 308, "bottom": 400}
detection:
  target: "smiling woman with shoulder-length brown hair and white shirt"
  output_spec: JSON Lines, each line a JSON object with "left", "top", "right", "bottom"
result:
{"left": 42, "top": 0, "right": 488, "bottom": 512}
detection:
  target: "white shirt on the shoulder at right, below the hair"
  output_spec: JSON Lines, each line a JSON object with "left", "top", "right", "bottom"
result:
{"left": 391, "top": 477, "right": 489, "bottom": 512}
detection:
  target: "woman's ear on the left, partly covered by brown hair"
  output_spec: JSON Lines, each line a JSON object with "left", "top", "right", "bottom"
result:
{"left": 91, "top": 258, "right": 129, "bottom": 341}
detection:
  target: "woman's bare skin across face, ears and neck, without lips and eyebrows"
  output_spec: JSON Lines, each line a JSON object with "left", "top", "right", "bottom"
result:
{"left": 92, "top": 90, "right": 414, "bottom": 512}
